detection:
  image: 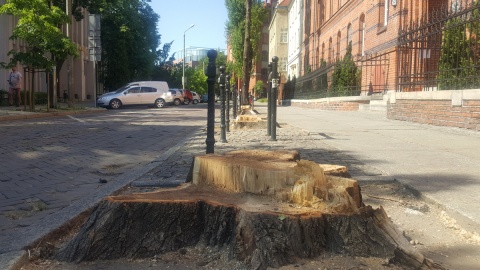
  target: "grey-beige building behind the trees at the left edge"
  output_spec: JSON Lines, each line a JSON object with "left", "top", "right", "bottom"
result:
{"left": 0, "top": 0, "right": 97, "bottom": 102}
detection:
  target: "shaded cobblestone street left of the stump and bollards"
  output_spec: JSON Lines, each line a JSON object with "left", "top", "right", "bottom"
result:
{"left": 0, "top": 105, "right": 207, "bottom": 253}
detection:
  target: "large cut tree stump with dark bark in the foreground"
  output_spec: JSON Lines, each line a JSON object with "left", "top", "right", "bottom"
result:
{"left": 56, "top": 150, "right": 432, "bottom": 269}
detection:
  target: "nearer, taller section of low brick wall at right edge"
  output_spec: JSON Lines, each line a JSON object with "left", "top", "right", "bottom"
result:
{"left": 387, "top": 90, "right": 480, "bottom": 131}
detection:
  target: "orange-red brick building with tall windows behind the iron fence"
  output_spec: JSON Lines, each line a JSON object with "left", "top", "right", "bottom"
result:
{"left": 301, "top": 0, "right": 449, "bottom": 94}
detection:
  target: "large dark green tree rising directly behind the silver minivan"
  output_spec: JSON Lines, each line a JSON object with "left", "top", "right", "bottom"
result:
{"left": 102, "top": 0, "right": 160, "bottom": 89}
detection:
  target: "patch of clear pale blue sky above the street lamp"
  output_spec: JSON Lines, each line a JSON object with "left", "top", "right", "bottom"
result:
{"left": 150, "top": 0, "right": 227, "bottom": 57}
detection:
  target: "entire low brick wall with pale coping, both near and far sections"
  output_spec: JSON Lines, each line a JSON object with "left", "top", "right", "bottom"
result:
{"left": 283, "top": 89, "right": 480, "bottom": 131}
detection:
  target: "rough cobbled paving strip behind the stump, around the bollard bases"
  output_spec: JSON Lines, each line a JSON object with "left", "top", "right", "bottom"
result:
{"left": 132, "top": 123, "right": 393, "bottom": 189}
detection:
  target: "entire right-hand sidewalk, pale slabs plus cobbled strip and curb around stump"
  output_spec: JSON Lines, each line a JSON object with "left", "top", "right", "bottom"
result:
{"left": 0, "top": 104, "right": 480, "bottom": 269}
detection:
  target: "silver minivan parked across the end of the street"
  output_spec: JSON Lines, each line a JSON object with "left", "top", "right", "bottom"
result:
{"left": 97, "top": 81, "right": 174, "bottom": 109}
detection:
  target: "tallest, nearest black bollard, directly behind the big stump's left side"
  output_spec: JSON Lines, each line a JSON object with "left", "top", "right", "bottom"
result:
{"left": 205, "top": 50, "right": 217, "bottom": 154}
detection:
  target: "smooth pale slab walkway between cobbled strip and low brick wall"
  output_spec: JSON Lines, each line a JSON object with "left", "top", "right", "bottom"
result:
{"left": 259, "top": 103, "right": 480, "bottom": 232}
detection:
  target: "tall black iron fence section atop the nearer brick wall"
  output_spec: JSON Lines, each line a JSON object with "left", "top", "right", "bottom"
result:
{"left": 397, "top": 1, "right": 480, "bottom": 91}
